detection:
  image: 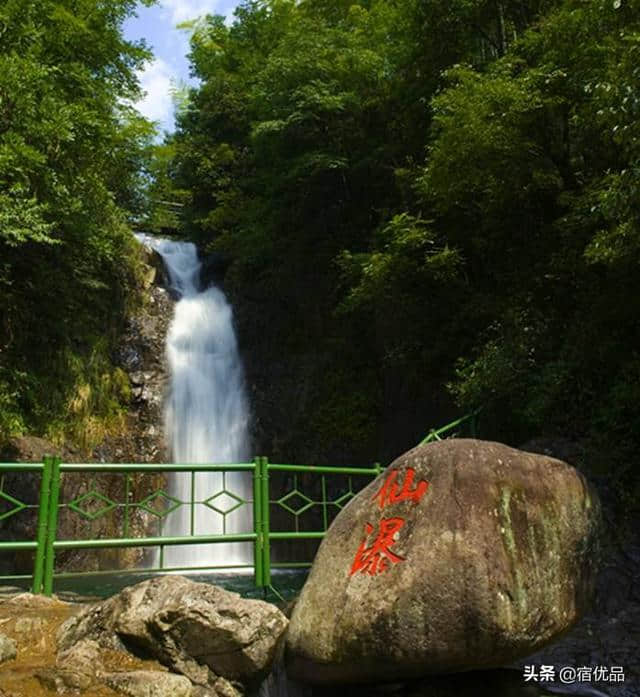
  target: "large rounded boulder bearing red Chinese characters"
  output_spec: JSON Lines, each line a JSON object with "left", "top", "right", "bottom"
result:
{"left": 286, "top": 439, "right": 600, "bottom": 683}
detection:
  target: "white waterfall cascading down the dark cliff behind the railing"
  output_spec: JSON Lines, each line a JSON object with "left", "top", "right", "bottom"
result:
{"left": 138, "top": 235, "right": 251, "bottom": 567}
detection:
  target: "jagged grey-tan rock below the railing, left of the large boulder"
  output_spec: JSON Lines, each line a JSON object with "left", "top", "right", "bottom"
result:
{"left": 58, "top": 576, "right": 287, "bottom": 686}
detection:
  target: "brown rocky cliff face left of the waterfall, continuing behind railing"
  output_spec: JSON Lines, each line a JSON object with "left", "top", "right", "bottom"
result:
{"left": 0, "top": 242, "right": 174, "bottom": 573}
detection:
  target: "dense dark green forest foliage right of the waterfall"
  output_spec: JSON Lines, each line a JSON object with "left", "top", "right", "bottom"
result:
{"left": 170, "top": 0, "right": 640, "bottom": 500}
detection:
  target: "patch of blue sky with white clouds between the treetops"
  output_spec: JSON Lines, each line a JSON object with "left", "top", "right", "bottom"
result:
{"left": 124, "top": 0, "right": 239, "bottom": 131}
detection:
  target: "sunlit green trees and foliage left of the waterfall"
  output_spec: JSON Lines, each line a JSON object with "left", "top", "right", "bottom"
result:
{"left": 0, "top": 0, "right": 152, "bottom": 444}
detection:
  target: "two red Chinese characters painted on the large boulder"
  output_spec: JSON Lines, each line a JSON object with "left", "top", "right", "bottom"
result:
{"left": 349, "top": 467, "right": 429, "bottom": 576}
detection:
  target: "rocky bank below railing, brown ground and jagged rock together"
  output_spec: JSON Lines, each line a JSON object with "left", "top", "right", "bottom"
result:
{"left": 0, "top": 576, "right": 287, "bottom": 697}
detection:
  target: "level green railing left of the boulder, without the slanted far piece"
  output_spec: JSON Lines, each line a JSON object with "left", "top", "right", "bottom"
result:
{"left": 0, "top": 456, "right": 381, "bottom": 595}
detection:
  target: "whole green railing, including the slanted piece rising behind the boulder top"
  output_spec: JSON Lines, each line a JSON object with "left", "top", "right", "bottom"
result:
{"left": 0, "top": 412, "right": 477, "bottom": 595}
